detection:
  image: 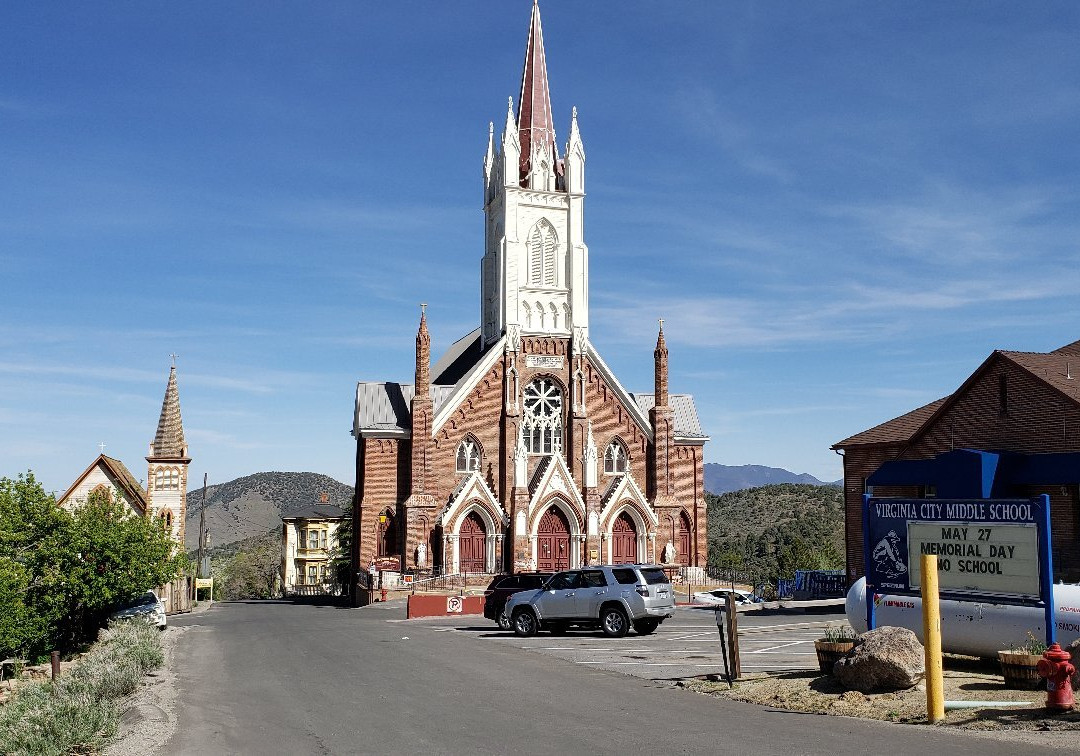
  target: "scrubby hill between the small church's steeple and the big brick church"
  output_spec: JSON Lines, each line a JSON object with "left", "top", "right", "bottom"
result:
{"left": 185, "top": 472, "right": 352, "bottom": 550}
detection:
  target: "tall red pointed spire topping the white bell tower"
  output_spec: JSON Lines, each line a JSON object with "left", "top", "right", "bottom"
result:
{"left": 517, "top": 0, "right": 563, "bottom": 191}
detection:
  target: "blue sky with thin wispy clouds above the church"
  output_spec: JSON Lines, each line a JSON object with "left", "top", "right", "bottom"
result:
{"left": 0, "top": 0, "right": 1080, "bottom": 490}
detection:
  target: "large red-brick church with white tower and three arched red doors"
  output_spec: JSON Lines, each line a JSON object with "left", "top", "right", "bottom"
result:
{"left": 352, "top": 3, "right": 708, "bottom": 591}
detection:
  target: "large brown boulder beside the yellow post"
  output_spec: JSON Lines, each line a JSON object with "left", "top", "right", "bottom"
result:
{"left": 833, "top": 627, "right": 926, "bottom": 693}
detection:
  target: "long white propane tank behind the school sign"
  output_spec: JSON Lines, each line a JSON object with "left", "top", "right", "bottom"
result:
{"left": 845, "top": 578, "right": 1080, "bottom": 659}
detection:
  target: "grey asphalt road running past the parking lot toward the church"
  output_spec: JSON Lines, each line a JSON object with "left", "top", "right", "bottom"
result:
{"left": 160, "top": 602, "right": 1050, "bottom": 756}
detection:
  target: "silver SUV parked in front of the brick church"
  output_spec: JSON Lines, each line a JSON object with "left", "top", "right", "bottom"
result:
{"left": 502, "top": 565, "right": 675, "bottom": 637}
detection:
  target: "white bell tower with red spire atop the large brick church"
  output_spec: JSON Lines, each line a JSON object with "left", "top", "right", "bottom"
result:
{"left": 481, "top": 0, "right": 589, "bottom": 349}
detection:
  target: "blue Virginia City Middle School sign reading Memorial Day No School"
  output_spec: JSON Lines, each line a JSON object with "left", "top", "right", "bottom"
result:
{"left": 863, "top": 496, "right": 1053, "bottom": 643}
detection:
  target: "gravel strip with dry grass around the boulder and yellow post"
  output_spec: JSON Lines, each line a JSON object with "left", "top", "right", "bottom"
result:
{"left": 680, "top": 657, "right": 1080, "bottom": 751}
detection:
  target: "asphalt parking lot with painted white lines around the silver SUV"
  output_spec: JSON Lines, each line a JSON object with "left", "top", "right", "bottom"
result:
{"left": 403, "top": 607, "right": 846, "bottom": 681}
